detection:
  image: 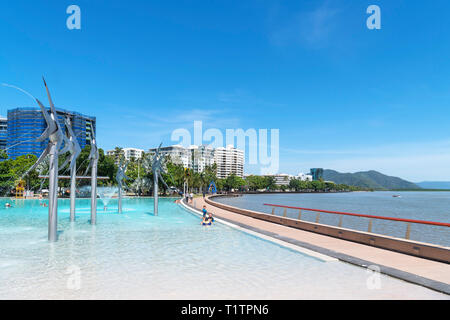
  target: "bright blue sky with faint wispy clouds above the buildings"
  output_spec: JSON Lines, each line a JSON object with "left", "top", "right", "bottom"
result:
{"left": 0, "top": 0, "right": 450, "bottom": 181}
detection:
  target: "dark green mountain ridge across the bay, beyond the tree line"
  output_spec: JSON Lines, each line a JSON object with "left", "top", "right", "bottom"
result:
{"left": 323, "top": 169, "right": 421, "bottom": 190}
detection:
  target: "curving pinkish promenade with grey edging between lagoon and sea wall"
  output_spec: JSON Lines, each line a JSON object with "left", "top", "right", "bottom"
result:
{"left": 183, "top": 197, "right": 450, "bottom": 295}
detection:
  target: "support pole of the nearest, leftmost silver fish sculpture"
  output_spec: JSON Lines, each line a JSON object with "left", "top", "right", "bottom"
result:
{"left": 48, "top": 143, "right": 58, "bottom": 242}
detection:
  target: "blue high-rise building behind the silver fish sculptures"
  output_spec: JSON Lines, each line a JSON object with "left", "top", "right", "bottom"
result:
{"left": 7, "top": 108, "right": 96, "bottom": 159}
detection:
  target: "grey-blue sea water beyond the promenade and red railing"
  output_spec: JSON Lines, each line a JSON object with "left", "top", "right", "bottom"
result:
{"left": 215, "top": 191, "right": 450, "bottom": 247}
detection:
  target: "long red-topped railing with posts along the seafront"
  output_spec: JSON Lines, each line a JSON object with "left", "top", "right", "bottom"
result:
{"left": 264, "top": 203, "right": 450, "bottom": 239}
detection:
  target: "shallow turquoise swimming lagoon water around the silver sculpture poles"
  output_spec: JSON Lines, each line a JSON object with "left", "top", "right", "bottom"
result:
{"left": 0, "top": 198, "right": 448, "bottom": 299}
